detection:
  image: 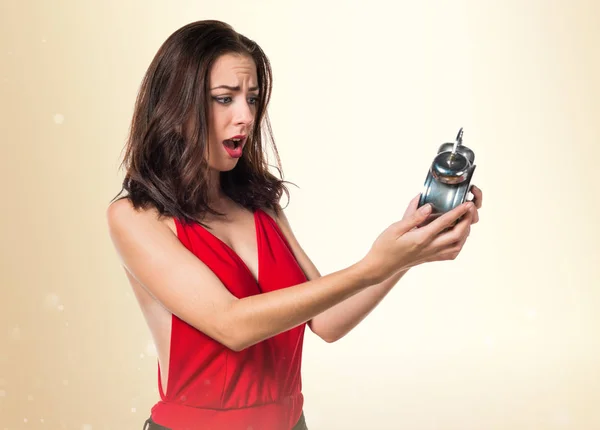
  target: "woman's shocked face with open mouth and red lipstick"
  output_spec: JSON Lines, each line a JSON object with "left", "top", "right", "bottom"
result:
{"left": 208, "top": 54, "right": 259, "bottom": 172}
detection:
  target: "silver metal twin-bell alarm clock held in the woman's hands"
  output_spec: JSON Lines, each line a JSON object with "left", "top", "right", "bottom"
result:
{"left": 419, "top": 128, "right": 475, "bottom": 222}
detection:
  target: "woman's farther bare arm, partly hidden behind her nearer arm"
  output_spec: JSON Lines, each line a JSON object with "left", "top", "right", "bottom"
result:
{"left": 269, "top": 209, "right": 408, "bottom": 342}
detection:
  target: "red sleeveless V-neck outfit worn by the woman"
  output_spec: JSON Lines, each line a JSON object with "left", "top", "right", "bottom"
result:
{"left": 152, "top": 210, "right": 307, "bottom": 430}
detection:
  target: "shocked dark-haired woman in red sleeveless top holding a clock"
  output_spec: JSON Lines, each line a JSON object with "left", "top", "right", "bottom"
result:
{"left": 107, "top": 21, "right": 481, "bottom": 430}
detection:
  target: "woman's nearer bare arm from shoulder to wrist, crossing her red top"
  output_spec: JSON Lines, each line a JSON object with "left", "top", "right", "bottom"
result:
{"left": 107, "top": 199, "right": 373, "bottom": 350}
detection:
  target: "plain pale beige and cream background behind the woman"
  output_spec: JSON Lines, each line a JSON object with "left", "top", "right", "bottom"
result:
{"left": 0, "top": 0, "right": 600, "bottom": 430}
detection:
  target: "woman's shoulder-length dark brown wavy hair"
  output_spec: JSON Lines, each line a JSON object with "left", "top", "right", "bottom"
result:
{"left": 113, "top": 20, "right": 289, "bottom": 223}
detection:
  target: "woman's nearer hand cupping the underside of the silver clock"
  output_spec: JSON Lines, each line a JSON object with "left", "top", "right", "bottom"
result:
{"left": 361, "top": 199, "right": 474, "bottom": 283}
